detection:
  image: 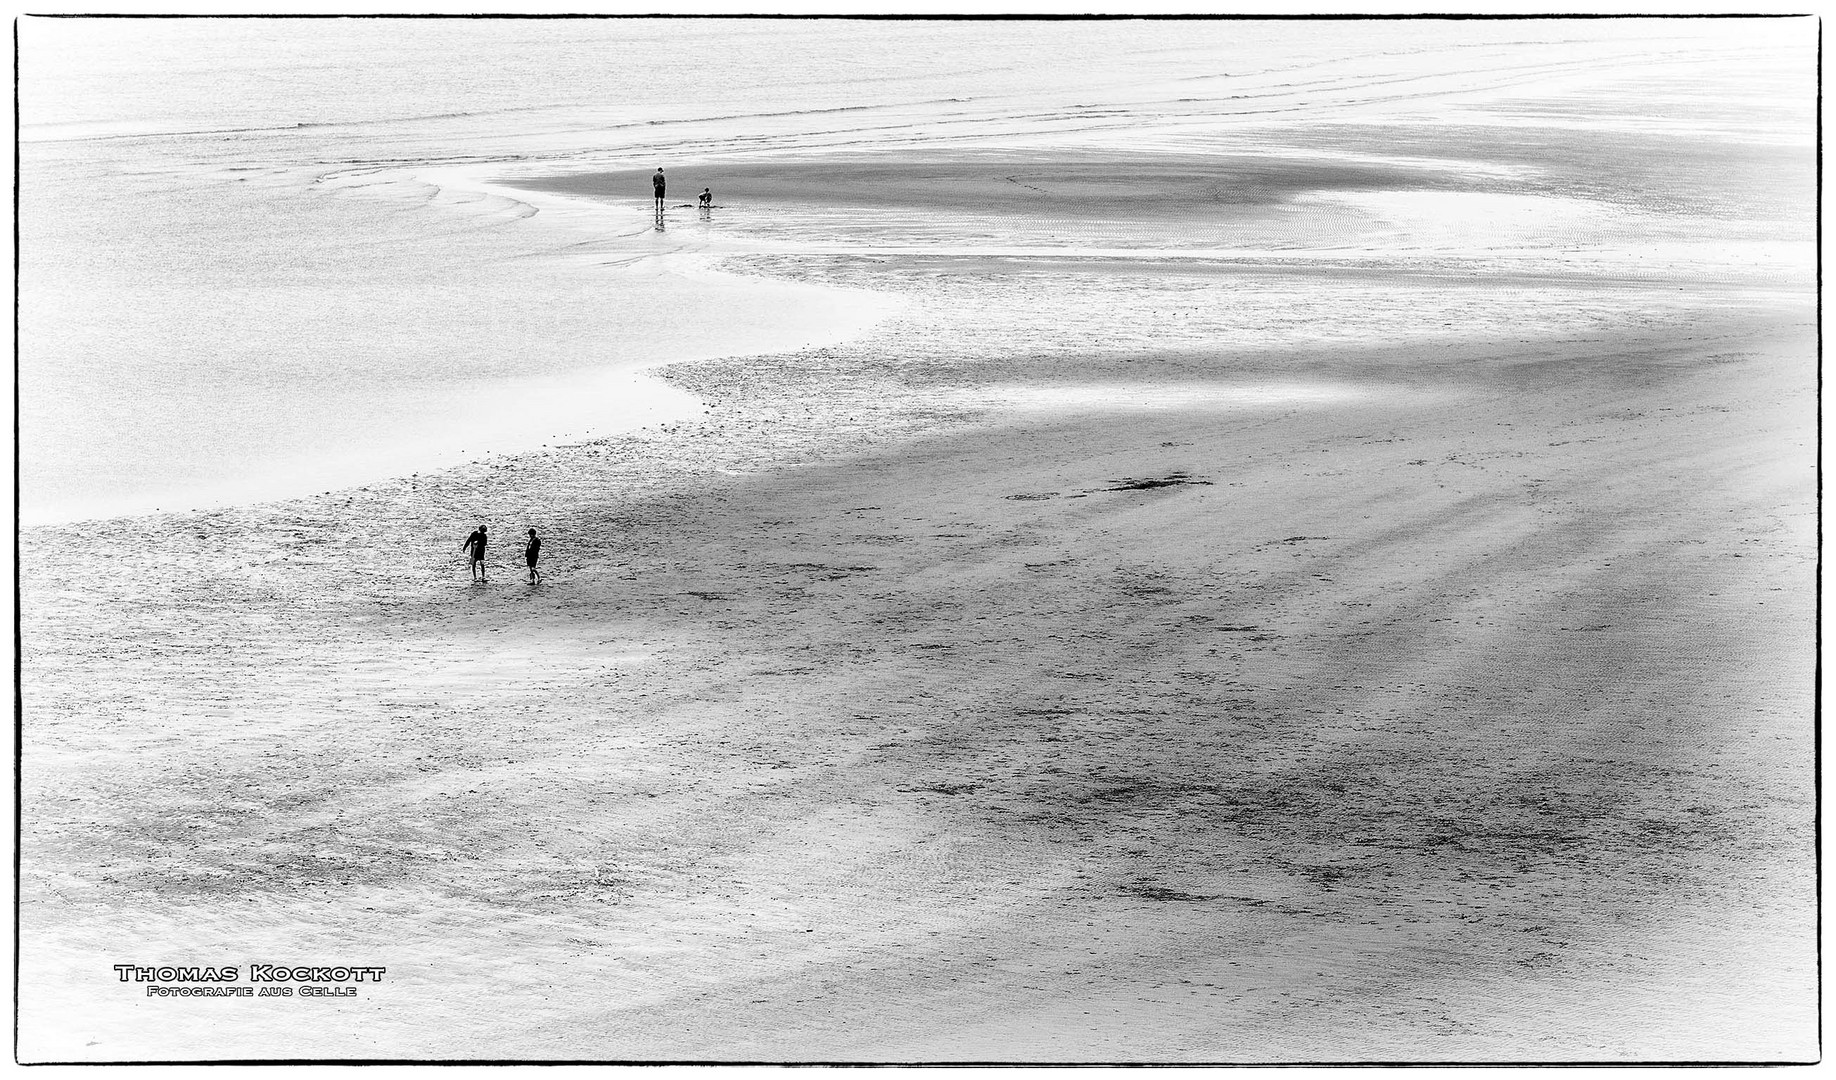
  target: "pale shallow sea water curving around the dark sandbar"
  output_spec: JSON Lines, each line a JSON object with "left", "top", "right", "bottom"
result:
{"left": 18, "top": 18, "right": 1814, "bottom": 523}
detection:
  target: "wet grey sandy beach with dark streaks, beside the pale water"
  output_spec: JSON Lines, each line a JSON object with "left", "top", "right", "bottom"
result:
{"left": 20, "top": 16, "right": 1818, "bottom": 1063}
